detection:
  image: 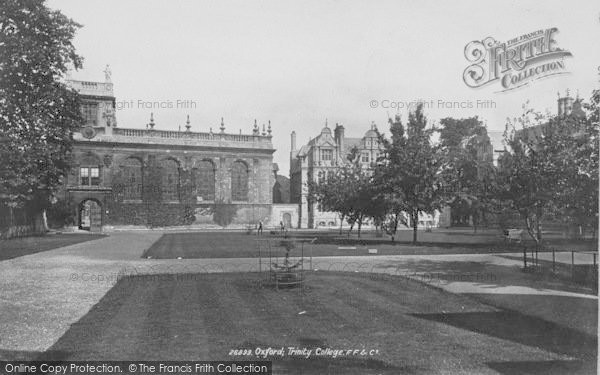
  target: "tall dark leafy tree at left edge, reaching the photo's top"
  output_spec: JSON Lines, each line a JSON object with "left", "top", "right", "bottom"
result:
{"left": 0, "top": 0, "right": 82, "bottom": 223}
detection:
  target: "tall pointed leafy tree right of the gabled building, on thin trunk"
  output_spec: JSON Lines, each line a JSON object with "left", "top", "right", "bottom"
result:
{"left": 379, "top": 104, "right": 442, "bottom": 243}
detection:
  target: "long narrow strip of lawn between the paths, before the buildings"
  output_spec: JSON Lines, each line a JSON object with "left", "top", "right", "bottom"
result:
{"left": 142, "top": 232, "right": 589, "bottom": 259}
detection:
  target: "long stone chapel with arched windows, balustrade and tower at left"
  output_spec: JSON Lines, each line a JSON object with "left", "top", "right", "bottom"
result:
{"left": 58, "top": 81, "right": 275, "bottom": 230}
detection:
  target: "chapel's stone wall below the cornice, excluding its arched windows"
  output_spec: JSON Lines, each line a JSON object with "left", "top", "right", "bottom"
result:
{"left": 59, "top": 142, "right": 274, "bottom": 227}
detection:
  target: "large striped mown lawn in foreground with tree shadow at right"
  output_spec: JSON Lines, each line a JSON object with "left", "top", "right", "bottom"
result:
{"left": 39, "top": 272, "right": 597, "bottom": 375}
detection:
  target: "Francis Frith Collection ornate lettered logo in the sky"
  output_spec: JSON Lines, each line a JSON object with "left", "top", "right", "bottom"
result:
{"left": 463, "top": 27, "right": 572, "bottom": 91}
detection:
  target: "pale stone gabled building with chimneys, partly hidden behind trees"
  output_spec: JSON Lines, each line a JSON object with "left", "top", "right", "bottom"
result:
{"left": 290, "top": 122, "right": 382, "bottom": 228}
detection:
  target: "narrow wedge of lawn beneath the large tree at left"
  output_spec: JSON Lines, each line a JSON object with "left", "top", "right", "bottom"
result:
{"left": 0, "top": 233, "right": 105, "bottom": 261}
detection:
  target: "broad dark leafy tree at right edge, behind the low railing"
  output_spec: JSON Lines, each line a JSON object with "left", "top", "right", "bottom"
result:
{"left": 500, "top": 100, "right": 598, "bottom": 245}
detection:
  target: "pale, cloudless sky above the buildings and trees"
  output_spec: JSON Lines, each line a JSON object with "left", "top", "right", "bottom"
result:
{"left": 47, "top": 0, "right": 600, "bottom": 175}
